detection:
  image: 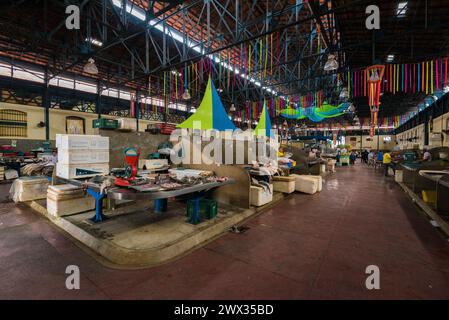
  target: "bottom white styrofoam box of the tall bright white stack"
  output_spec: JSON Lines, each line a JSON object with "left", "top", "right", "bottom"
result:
{"left": 56, "top": 163, "right": 109, "bottom": 179}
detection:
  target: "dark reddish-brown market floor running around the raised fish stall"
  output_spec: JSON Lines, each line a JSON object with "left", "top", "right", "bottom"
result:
{"left": 0, "top": 165, "right": 449, "bottom": 299}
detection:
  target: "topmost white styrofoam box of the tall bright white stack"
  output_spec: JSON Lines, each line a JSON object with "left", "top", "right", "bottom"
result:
{"left": 56, "top": 134, "right": 109, "bottom": 150}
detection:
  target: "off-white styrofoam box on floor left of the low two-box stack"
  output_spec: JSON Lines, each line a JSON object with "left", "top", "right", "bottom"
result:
{"left": 9, "top": 177, "right": 49, "bottom": 203}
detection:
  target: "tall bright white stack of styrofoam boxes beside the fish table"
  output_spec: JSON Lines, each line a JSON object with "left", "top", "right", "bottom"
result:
{"left": 56, "top": 134, "right": 109, "bottom": 179}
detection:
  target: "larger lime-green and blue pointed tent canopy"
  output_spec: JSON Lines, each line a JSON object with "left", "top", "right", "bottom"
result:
{"left": 177, "top": 77, "right": 235, "bottom": 131}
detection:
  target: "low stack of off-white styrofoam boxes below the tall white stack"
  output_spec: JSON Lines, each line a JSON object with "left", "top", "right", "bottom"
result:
{"left": 47, "top": 184, "right": 95, "bottom": 217}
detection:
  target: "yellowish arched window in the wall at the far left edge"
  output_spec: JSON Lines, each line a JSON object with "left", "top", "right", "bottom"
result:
{"left": 0, "top": 109, "right": 27, "bottom": 137}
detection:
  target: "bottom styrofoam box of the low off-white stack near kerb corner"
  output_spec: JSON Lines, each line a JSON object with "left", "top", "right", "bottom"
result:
{"left": 47, "top": 196, "right": 95, "bottom": 217}
